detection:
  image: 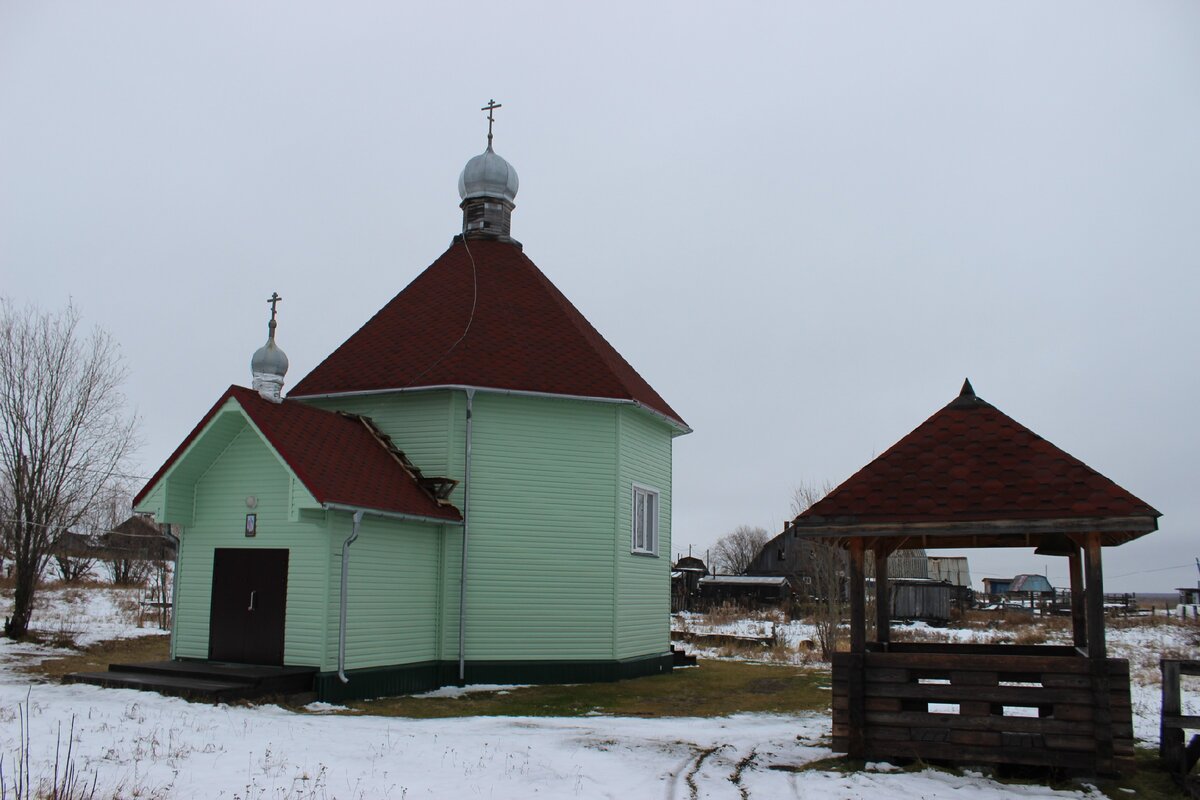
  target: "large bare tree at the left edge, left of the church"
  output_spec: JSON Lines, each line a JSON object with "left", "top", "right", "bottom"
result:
{"left": 0, "top": 297, "right": 137, "bottom": 638}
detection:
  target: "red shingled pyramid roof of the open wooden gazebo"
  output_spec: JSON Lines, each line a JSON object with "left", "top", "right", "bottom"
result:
{"left": 796, "top": 383, "right": 1160, "bottom": 533}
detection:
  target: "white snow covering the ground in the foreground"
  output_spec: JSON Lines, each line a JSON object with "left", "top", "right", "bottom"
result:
{"left": 0, "top": 590, "right": 1175, "bottom": 800}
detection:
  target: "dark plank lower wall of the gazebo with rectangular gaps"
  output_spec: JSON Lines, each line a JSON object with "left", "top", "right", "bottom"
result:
{"left": 833, "top": 643, "right": 1134, "bottom": 774}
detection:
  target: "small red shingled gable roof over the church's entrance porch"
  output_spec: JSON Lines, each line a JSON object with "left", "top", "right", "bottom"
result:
{"left": 133, "top": 386, "right": 462, "bottom": 521}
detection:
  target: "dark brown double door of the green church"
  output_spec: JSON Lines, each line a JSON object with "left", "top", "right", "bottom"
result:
{"left": 209, "top": 548, "right": 288, "bottom": 664}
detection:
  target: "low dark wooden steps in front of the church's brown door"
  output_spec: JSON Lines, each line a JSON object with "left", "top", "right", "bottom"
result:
{"left": 62, "top": 661, "right": 317, "bottom": 703}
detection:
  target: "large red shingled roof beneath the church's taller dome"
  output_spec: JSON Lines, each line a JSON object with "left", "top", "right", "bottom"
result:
{"left": 289, "top": 239, "right": 686, "bottom": 427}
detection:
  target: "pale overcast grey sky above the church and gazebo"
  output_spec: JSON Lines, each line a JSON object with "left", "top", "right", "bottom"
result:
{"left": 0, "top": 0, "right": 1200, "bottom": 591}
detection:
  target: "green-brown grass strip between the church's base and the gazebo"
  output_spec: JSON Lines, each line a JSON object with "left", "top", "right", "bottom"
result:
{"left": 333, "top": 661, "right": 830, "bottom": 718}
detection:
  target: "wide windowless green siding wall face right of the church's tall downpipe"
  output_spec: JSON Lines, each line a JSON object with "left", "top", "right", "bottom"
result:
{"left": 443, "top": 393, "right": 617, "bottom": 661}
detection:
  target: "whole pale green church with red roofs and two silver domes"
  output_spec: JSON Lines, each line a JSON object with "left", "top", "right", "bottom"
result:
{"left": 134, "top": 120, "right": 690, "bottom": 699}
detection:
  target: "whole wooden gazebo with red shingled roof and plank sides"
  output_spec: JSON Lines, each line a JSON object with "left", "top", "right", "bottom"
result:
{"left": 791, "top": 381, "right": 1160, "bottom": 774}
